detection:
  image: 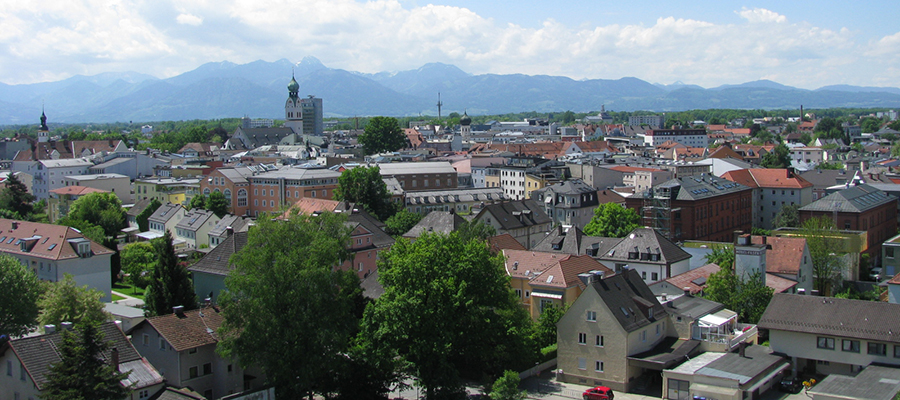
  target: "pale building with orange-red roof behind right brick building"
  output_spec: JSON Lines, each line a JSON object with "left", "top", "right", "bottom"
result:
{"left": 722, "top": 168, "right": 813, "bottom": 230}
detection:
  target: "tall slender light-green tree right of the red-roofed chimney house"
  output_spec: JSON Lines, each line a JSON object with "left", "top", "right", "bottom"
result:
{"left": 800, "top": 216, "right": 845, "bottom": 296}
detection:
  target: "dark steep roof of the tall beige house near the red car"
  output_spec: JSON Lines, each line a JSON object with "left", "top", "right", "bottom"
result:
{"left": 590, "top": 269, "right": 667, "bottom": 332}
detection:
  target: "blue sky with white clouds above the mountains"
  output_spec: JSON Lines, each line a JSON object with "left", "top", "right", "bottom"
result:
{"left": 0, "top": 0, "right": 900, "bottom": 89}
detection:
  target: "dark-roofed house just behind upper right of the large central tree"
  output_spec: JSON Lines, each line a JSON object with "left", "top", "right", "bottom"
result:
{"left": 474, "top": 200, "right": 553, "bottom": 248}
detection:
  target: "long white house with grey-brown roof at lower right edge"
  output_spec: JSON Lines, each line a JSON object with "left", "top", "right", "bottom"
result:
{"left": 759, "top": 294, "right": 900, "bottom": 376}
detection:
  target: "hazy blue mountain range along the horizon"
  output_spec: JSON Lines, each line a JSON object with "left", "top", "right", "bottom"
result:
{"left": 0, "top": 57, "right": 900, "bottom": 124}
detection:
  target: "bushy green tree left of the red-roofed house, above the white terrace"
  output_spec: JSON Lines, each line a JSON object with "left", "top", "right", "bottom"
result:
{"left": 703, "top": 267, "right": 774, "bottom": 324}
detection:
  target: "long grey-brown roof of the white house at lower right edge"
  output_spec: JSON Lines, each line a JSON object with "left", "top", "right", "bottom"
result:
{"left": 758, "top": 293, "right": 900, "bottom": 344}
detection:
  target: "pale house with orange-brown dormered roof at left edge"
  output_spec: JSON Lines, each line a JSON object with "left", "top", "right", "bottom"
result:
{"left": 0, "top": 219, "right": 114, "bottom": 301}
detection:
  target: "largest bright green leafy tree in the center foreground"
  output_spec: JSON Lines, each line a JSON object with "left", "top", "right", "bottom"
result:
{"left": 360, "top": 232, "right": 537, "bottom": 400}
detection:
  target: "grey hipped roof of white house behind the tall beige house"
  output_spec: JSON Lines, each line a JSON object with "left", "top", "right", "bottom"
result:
{"left": 597, "top": 228, "right": 692, "bottom": 264}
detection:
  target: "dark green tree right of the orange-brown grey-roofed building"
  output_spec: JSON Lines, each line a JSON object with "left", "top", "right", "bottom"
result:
{"left": 334, "top": 166, "right": 405, "bottom": 222}
